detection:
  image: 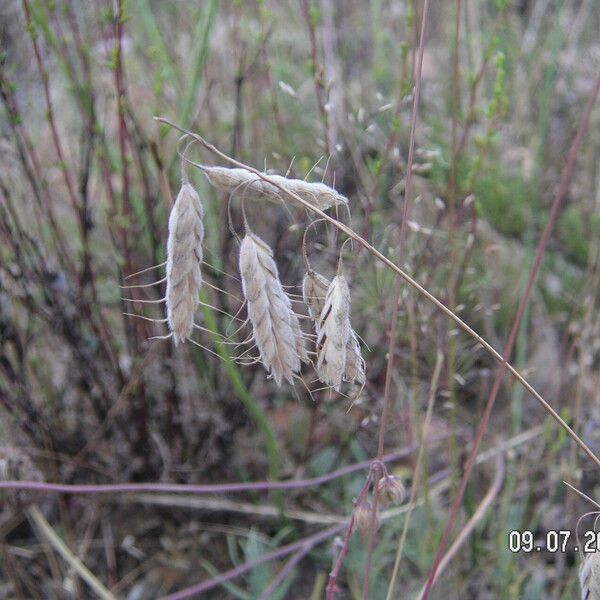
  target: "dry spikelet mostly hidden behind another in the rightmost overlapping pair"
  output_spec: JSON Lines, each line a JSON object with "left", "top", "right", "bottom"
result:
{"left": 302, "top": 270, "right": 365, "bottom": 385}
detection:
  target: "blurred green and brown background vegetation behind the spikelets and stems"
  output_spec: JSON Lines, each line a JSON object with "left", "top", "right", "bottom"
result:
{"left": 0, "top": 0, "right": 600, "bottom": 600}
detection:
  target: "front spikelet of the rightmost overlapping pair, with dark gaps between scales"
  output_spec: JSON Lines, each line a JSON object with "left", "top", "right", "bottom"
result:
{"left": 316, "top": 275, "right": 351, "bottom": 390}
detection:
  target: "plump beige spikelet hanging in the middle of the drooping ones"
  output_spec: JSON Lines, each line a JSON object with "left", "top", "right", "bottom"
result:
{"left": 240, "top": 232, "right": 308, "bottom": 385}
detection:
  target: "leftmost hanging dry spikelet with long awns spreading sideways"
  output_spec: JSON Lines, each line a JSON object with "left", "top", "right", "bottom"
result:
{"left": 166, "top": 183, "right": 204, "bottom": 345}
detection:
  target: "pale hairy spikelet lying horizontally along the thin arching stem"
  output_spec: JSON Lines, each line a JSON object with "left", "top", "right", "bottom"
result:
{"left": 201, "top": 165, "right": 348, "bottom": 210}
